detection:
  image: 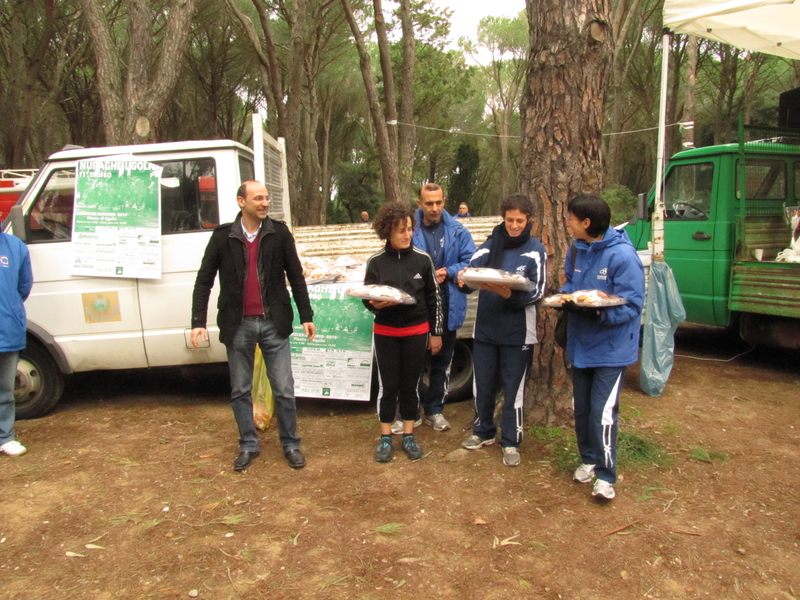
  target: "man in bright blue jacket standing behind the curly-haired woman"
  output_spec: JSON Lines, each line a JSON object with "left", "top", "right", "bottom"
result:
{"left": 392, "top": 183, "right": 475, "bottom": 434}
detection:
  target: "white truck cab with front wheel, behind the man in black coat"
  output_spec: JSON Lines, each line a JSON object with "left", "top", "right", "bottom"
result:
{"left": 4, "top": 136, "right": 288, "bottom": 419}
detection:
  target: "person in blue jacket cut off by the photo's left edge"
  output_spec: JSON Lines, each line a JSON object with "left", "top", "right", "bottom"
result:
{"left": 0, "top": 222, "right": 33, "bottom": 456}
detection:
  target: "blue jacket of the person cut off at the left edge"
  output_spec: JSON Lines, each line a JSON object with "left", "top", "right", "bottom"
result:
{"left": 0, "top": 232, "right": 33, "bottom": 352}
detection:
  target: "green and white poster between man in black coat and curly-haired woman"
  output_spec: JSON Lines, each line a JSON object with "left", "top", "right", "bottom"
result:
{"left": 291, "top": 283, "right": 373, "bottom": 401}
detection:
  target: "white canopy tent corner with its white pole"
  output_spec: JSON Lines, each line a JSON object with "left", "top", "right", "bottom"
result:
{"left": 653, "top": 0, "right": 800, "bottom": 260}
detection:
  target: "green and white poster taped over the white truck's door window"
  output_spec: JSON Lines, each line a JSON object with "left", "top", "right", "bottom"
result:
{"left": 70, "top": 155, "right": 162, "bottom": 279}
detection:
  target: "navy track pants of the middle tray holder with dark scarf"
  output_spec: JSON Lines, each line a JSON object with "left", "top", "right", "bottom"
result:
{"left": 472, "top": 340, "right": 533, "bottom": 448}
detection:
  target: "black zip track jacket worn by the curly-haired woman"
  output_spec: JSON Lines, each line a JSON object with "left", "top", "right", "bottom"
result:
{"left": 364, "top": 242, "right": 442, "bottom": 335}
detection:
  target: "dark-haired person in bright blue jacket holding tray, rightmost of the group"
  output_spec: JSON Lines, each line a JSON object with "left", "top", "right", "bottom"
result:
{"left": 559, "top": 194, "right": 645, "bottom": 501}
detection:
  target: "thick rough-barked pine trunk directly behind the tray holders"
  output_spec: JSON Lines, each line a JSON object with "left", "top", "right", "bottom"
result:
{"left": 519, "top": 0, "right": 611, "bottom": 425}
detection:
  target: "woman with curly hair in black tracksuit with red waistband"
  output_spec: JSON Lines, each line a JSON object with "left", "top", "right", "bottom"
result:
{"left": 364, "top": 202, "right": 442, "bottom": 462}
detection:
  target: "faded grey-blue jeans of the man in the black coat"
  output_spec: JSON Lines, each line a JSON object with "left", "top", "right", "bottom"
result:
{"left": 226, "top": 316, "right": 300, "bottom": 452}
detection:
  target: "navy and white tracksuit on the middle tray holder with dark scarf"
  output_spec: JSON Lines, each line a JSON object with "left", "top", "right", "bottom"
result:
{"left": 470, "top": 232, "right": 547, "bottom": 448}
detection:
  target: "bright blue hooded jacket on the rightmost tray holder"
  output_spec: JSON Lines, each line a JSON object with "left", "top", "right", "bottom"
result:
{"left": 559, "top": 227, "right": 644, "bottom": 369}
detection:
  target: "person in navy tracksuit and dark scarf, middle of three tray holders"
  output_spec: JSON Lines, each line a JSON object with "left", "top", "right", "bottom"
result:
{"left": 459, "top": 194, "right": 547, "bottom": 467}
